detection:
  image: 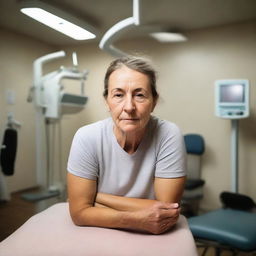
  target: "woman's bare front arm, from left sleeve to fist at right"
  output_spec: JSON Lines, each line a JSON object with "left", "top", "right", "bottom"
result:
{"left": 67, "top": 173, "right": 179, "bottom": 234}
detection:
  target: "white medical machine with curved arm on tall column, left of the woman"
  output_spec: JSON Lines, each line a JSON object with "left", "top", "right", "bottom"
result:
{"left": 23, "top": 51, "right": 88, "bottom": 201}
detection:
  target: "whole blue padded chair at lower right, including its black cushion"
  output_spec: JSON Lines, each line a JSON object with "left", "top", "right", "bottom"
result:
{"left": 188, "top": 192, "right": 256, "bottom": 256}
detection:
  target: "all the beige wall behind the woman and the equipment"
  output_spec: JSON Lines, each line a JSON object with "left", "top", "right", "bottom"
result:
{"left": 0, "top": 20, "right": 256, "bottom": 209}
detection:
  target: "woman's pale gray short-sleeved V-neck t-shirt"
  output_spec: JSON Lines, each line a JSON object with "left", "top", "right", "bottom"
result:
{"left": 67, "top": 117, "right": 186, "bottom": 199}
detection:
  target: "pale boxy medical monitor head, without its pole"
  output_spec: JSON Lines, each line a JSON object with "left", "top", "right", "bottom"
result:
{"left": 215, "top": 79, "right": 249, "bottom": 119}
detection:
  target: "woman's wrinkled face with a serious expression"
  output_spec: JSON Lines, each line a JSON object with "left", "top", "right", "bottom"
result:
{"left": 106, "top": 66, "right": 156, "bottom": 134}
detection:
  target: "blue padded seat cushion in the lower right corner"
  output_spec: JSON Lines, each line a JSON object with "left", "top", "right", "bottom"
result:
{"left": 188, "top": 209, "right": 256, "bottom": 251}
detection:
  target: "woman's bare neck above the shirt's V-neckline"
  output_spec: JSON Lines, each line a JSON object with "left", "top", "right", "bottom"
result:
{"left": 114, "top": 127, "right": 145, "bottom": 154}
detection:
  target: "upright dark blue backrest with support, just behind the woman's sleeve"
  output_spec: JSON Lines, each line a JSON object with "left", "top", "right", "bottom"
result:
{"left": 184, "top": 134, "right": 205, "bottom": 179}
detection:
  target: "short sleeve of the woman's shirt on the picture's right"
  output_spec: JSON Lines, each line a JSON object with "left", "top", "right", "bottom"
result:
{"left": 155, "top": 121, "right": 186, "bottom": 178}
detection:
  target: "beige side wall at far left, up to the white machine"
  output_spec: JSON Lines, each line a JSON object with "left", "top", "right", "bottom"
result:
{"left": 0, "top": 29, "right": 54, "bottom": 191}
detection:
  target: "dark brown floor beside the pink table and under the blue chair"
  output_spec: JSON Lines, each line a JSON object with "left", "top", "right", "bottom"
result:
{"left": 0, "top": 189, "right": 255, "bottom": 256}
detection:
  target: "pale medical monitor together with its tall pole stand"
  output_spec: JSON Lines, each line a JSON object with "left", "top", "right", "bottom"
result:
{"left": 215, "top": 79, "right": 249, "bottom": 193}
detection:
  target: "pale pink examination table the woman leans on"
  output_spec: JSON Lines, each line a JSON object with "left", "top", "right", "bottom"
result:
{"left": 0, "top": 203, "right": 198, "bottom": 256}
